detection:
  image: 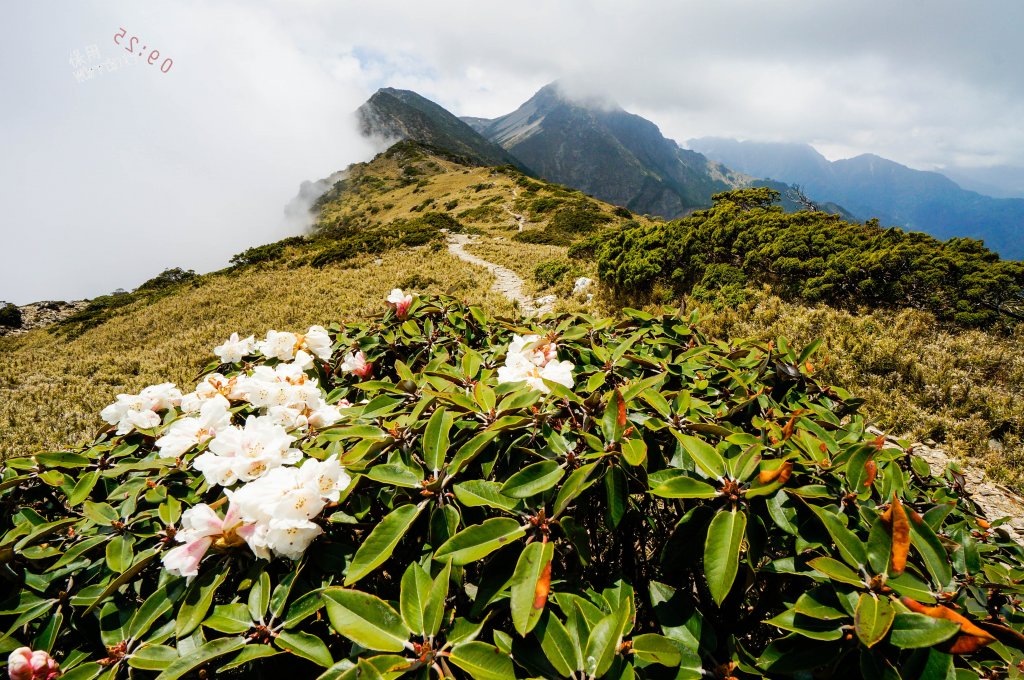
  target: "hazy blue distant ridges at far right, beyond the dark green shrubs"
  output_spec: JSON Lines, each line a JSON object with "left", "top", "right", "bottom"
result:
{"left": 687, "top": 138, "right": 1024, "bottom": 259}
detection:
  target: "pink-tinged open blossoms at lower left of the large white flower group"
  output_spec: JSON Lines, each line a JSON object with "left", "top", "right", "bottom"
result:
{"left": 163, "top": 503, "right": 255, "bottom": 577}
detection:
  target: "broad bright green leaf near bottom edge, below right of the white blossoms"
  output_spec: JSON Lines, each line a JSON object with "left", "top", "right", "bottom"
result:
{"left": 324, "top": 588, "right": 410, "bottom": 651}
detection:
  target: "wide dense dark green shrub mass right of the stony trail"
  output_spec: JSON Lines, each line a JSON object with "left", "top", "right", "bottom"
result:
{"left": 597, "top": 187, "right": 1024, "bottom": 328}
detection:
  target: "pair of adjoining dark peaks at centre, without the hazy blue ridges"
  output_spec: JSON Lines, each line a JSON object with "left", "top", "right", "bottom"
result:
{"left": 358, "top": 84, "right": 752, "bottom": 218}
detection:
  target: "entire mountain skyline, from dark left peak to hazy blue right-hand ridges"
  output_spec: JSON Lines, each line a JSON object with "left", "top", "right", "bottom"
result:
{"left": 357, "top": 83, "right": 1024, "bottom": 259}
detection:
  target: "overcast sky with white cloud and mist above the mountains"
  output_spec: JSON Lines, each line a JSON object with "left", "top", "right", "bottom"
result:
{"left": 0, "top": 0, "right": 1024, "bottom": 303}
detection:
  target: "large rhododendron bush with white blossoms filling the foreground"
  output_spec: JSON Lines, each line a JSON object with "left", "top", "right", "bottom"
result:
{"left": 0, "top": 290, "right": 1024, "bottom": 680}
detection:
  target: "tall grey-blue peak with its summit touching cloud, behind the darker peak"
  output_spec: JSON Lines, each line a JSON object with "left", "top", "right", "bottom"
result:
{"left": 470, "top": 83, "right": 749, "bottom": 217}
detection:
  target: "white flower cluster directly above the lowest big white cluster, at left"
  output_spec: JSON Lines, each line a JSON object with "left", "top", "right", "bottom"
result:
{"left": 193, "top": 416, "right": 302, "bottom": 486}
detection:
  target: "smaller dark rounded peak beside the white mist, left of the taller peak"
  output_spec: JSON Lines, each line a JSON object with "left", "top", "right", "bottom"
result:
{"left": 356, "top": 87, "right": 522, "bottom": 169}
